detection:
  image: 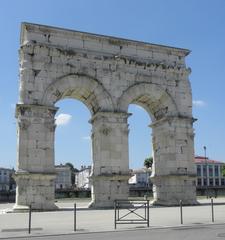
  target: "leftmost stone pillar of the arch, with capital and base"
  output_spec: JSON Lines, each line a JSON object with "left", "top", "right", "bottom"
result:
{"left": 14, "top": 104, "right": 57, "bottom": 211}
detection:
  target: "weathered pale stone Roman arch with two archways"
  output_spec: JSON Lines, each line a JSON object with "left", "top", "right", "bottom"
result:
{"left": 14, "top": 23, "right": 196, "bottom": 210}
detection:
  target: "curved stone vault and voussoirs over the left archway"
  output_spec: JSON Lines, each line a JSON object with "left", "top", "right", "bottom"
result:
{"left": 41, "top": 74, "right": 113, "bottom": 114}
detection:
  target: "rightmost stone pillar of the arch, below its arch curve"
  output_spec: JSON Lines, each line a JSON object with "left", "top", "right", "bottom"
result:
{"left": 151, "top": 117, "right": 197, "bottom": 206}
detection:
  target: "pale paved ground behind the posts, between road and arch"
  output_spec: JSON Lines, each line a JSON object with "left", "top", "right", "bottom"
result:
{"left": 0, "top": 198, "right": 225, "bottom": 239}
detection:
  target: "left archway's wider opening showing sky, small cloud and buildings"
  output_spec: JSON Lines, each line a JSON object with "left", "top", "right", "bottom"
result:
{"left": 55, "top": 99, "right": 93, "bottom": 196}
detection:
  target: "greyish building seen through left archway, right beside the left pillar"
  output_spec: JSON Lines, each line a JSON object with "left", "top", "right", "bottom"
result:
{"left": 55, "top": 164, "right": 72, "bottom": 190}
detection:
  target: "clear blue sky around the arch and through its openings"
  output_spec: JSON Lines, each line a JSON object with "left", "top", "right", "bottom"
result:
{"left": 0, "top": 0, "right": 225, "bottom": 168}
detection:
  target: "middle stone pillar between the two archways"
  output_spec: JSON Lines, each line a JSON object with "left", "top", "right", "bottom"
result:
{"left": 90, "top": 112, "right": 130, "bottom": 208}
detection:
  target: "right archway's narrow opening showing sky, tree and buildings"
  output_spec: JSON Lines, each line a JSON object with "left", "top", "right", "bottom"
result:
{"left": 128, "top": 104, "right": 153, "bottom": 197}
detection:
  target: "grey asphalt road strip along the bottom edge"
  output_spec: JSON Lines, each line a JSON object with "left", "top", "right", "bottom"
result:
{"left": 3, "top": 224, "right": 225, "bottom": 240}
